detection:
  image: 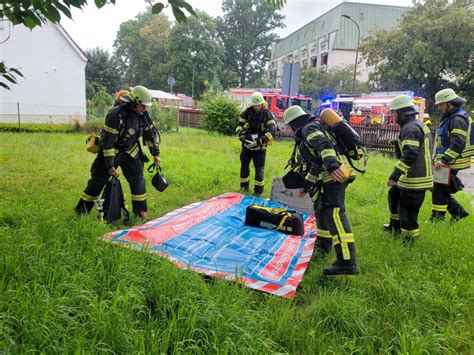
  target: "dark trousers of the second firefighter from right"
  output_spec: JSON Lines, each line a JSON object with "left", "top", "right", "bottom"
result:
{"left": 388, "top": 186, "right": 426, "bottom": 240}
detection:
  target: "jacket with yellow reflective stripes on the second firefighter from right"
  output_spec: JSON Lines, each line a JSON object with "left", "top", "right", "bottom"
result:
{"left": 390, "top": 116, "right": 433, "bottom": 190}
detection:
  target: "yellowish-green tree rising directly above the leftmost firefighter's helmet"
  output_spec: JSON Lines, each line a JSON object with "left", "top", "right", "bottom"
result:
{"left": 114, "top": 11, "right": 171, "bottom": 88}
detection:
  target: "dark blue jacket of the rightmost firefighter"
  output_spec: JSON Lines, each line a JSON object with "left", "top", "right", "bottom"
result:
{"left": 435, "top": 107, "right": 471, "bottom": 170}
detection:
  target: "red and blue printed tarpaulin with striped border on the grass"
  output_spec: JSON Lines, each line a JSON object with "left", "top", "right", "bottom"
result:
{"left": 103, "top": 193, "right": 316, "bottom": 298}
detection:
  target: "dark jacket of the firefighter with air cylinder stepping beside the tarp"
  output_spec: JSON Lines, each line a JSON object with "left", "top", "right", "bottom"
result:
{"left": 295, "top": 121, "right": 355, "bottom": 184}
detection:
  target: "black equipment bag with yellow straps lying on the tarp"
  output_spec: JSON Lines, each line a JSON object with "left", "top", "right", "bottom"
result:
{"left": 245, "top": 205, "right": 304, "bottom": 235}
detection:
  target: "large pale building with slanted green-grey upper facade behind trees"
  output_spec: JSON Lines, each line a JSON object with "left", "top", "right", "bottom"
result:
{"left": 269, "top": 2, "right": 409, "bottom": 87}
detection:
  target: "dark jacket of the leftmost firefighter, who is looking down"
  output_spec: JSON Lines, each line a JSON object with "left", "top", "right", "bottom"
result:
{"left": 100, "top": 103, "right": 160, "bottom": 168}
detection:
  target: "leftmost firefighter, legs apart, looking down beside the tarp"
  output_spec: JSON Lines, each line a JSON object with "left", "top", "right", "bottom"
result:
{"left": 75, "top": 86, "right": 160, "bottom": 218}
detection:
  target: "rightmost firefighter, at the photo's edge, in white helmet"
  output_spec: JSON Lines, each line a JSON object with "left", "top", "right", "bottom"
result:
{"left": 430, "top": 89, "right": 470, "bottom": 222}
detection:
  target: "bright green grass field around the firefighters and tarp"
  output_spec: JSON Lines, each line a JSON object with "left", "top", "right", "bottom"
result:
{"left": 0, "top": 128, "right": 474, "bottom": 354}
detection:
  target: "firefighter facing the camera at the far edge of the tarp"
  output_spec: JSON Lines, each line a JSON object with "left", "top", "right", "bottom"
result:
{"left": 235, "top": 92, "right": 276, "bottom": 197}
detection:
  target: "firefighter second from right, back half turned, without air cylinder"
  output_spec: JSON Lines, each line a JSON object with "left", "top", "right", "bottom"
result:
{"left": 383, "top": 95, "right": 433, "bottom": 243}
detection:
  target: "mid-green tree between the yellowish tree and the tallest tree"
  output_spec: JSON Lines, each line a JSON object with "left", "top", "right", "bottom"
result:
{"left": 170, "top": 12, "right": 224, "bottom": 98}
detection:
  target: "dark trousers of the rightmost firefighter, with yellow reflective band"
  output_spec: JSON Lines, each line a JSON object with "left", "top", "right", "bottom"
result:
{"left": 431, "top": 170, "right": 469, "bottom": 220}
